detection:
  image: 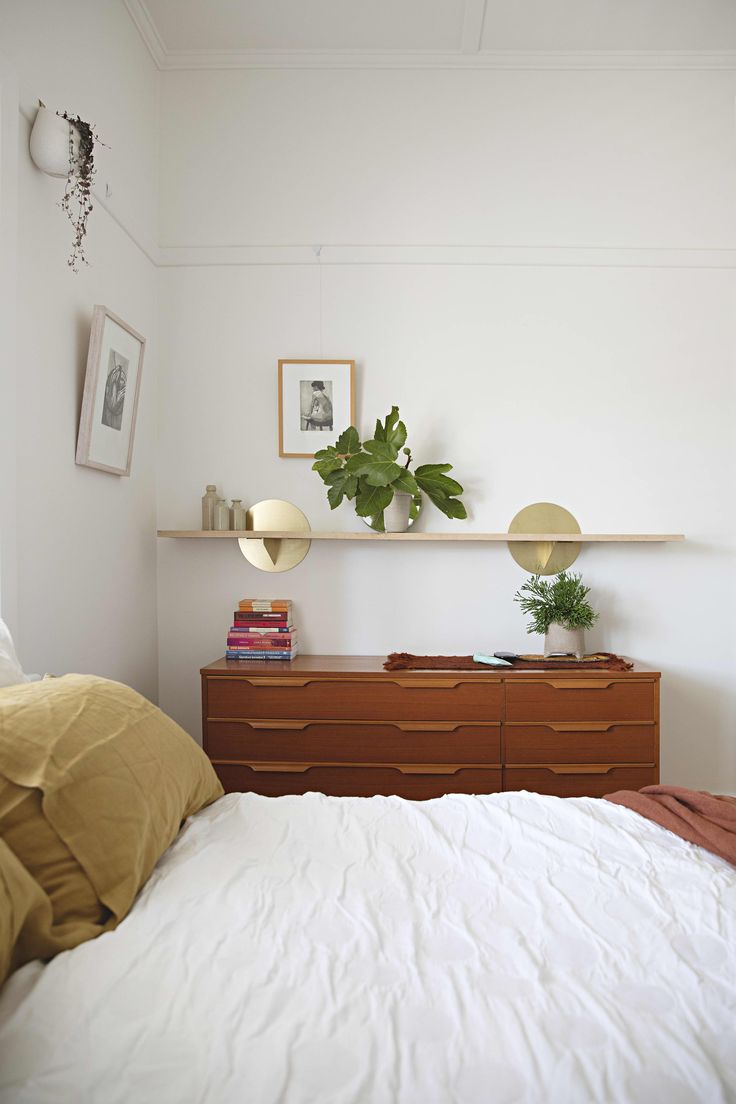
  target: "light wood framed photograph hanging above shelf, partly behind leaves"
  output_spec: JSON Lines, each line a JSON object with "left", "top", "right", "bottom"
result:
{"left": 278, "top": 360, "right": 355, "bottom": 459}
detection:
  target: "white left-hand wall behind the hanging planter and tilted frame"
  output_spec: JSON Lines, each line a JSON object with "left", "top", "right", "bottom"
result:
{"left": 0, "top": 0, "right": 158, "bottom": 698}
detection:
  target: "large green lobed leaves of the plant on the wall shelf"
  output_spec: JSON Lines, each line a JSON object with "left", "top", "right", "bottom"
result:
{"left": 312, "top": 406, "right": 468, "bottom": 532}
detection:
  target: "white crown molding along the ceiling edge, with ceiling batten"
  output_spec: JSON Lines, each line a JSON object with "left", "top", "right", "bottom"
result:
{"left": 122, "top": 0, "right": 736, "bottom": 71}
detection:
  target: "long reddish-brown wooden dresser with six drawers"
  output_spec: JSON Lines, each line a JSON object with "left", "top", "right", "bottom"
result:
{"left": 201, "top": 656, "right": 660, "bottom": 799}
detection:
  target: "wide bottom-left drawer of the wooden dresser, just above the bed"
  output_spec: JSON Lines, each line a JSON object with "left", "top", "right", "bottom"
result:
{"left": 209, "top": 763, "right": 501, "bottom": 800}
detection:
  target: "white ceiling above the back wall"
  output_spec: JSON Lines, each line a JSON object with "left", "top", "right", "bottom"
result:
{"left": 125, "top": 0, "right": 736, "bottom": 63}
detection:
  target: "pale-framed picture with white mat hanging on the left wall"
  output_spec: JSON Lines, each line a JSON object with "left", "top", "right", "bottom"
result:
{"left": 76, "top": 306, "right": 146, "bottom": 476}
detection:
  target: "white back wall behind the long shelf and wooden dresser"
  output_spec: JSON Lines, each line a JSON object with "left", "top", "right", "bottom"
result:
{"left": 159, "top": 62, "right": 736, "bottom": 789}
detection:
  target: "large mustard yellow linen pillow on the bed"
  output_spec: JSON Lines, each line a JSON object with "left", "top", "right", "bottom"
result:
{"left": 0, "top": 675, "right": 223, "bottom": 965}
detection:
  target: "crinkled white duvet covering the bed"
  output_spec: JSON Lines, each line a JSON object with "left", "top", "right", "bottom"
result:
{"left": 0, "top": 793, "right": 736, "bottom": 1104}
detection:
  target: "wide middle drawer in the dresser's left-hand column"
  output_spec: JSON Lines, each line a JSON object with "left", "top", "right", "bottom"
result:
{"left": 205, "top": 719, "right": 501, "bottom": 765}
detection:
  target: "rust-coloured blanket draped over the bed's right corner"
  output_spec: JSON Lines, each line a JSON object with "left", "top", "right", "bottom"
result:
{"left": 605, "top": 786, "right": 736, "bottom": 867}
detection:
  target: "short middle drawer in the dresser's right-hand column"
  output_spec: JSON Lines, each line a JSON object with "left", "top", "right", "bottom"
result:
{"left": 503, "top": 721, "right": 657, "bottom": 765}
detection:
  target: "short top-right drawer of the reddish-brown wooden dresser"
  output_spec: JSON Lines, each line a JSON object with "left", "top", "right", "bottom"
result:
{"left": 505, "top": 678, "right": 657, "bottom": 722}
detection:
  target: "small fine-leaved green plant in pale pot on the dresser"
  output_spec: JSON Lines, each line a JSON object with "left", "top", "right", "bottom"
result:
{"left": 514, "top": 571, "right": 598, "bottom": 659}
